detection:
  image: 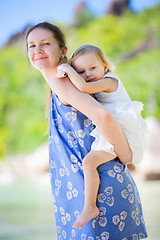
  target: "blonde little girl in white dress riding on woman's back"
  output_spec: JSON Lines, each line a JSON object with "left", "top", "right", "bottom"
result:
{"left": 57, "top": 45, "right": 147, "bottom": 228}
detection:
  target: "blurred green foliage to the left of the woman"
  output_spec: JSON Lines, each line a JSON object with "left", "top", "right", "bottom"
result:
{"left": 0, "top": 46, "right": 47, "bottom": 157}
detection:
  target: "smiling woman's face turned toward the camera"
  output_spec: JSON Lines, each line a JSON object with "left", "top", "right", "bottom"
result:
{"left": 27, "top": 28, "right": 62, "bottom": 71}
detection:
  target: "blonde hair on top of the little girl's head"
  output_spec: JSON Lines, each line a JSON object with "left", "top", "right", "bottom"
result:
{"left": 68, "top": 44, "right": 115, "bottom": 72}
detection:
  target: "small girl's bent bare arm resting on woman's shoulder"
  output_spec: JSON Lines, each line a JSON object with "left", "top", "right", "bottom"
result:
{"left": 57, "top": 64, "right": 118, "bottom": 94}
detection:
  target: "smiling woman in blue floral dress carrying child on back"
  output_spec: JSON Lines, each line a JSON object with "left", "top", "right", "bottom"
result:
{"left": 26, "top": 23, "right": 147, "bottom": 240}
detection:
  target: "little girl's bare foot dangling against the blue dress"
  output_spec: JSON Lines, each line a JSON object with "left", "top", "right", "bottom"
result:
{"left": 72, "top": 207, "right": 99, "bottom": 228}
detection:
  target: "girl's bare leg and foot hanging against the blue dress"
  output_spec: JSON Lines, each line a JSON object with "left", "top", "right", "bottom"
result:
{"left": 73, "top": 151, "right": 115, "bottom": 228}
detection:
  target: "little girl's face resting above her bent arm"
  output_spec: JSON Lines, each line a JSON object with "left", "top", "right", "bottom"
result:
{"left": 73, "top": 52, "right": 107, "bottom": 82}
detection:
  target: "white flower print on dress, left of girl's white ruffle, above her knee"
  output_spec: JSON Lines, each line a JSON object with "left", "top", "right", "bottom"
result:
{"left": 67, "top": 129, "right": 86, "bottom": 148}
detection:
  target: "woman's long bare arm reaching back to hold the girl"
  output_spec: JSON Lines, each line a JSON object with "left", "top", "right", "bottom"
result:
{"left": 48, "top": 77, "right": 132, "bottom": 164}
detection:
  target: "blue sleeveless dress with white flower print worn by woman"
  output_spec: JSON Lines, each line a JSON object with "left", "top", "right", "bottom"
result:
{"left": 49, "top": 94, "right": 147, "bottom": 240}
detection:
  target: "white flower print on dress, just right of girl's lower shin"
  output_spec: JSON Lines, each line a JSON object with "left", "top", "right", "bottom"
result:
{"left": 97, "top": 187, "right": 114, "bottom": 206}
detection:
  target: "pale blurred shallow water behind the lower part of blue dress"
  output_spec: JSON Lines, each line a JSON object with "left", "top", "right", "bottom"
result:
{"left": 0, "top": 175, "right": 160, "bottom": 240}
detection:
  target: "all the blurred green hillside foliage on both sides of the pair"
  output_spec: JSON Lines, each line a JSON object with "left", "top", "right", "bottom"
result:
{"left": 0, "top": 5, "right": 160, "bottom": 158}
